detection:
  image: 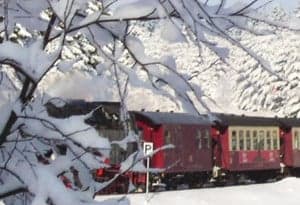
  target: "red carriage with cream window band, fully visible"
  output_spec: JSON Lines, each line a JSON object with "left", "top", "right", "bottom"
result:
{"left": 213, "top": 114, "right": 280, "bottom": 181}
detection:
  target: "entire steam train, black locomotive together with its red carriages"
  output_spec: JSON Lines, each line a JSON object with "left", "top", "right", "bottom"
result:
{"left": 45, "top": 100, "right": 300, "bottom": 194}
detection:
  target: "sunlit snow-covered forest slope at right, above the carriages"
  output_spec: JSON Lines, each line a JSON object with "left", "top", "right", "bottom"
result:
{"left": 126, "top": 7, "right": 300, "bottom": 116}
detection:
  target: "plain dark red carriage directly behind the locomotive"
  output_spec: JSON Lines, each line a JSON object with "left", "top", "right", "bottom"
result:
{"left": 132, "top": 112, "right": 212, "bottom": 188}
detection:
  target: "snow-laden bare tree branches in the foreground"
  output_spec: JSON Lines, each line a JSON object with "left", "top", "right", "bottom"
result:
{"left": 0, "top": 0, "right": 300, "bottom": 205}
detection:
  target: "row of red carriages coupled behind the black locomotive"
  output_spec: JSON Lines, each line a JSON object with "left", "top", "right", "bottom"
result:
{"left": 95, "top": 112, "right": 300, "bottom": 193}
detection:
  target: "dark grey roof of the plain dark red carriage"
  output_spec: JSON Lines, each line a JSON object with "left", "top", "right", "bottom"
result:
{"left": 130, "top": 111, "right": 212, "bottom": 125}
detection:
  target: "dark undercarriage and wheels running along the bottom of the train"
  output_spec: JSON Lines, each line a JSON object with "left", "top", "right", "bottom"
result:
{"left": 98, "top": 169, "right": 288, "bottom": 194}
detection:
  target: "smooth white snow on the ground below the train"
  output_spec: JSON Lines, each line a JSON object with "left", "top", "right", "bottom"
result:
{"left": 97, "top": 178, "right": 300, "bottom": 205}
